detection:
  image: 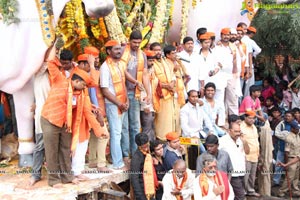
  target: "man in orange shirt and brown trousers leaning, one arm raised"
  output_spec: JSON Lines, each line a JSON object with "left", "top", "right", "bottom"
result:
{"left": 41, "top": 47, "right": 106, "bottom": 187}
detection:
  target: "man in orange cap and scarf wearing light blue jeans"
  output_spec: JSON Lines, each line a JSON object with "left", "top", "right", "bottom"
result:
{"left": 100, "top": 40, "right": 129, "bottom": 170}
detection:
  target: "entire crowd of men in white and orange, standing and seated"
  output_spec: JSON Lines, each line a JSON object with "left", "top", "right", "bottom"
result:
{"left": 0, "top": 20, "right": 300, "bottom": 200}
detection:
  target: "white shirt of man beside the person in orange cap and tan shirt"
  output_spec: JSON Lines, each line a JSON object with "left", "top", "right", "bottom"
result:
{"left": 219, "top": 133, "right": 246, "bottom": 177}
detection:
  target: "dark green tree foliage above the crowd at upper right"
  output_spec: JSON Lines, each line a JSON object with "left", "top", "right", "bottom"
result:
{"left": 252, "top": 0, "right": 300, "bottom": 79}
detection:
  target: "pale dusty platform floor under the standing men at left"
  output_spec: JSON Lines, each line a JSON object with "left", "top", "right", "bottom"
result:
{"left": 0, "top": 159, "right": 128, "bottom": 200}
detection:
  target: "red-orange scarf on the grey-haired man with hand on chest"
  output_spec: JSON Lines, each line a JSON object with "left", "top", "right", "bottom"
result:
{"left": 199, "top": 171, "right": 229, "bottom": 200}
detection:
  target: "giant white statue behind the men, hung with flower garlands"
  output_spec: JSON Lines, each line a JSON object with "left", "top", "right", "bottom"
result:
{"left": 0, "top": 0, "right": 114, "bottom": 166}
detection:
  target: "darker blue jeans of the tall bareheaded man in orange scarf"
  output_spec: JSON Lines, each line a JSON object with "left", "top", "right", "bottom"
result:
{"left": 121, "top": 92, "right": 141, "bottom": 157}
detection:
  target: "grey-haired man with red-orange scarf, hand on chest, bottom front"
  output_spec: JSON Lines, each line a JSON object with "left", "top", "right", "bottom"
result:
{"left": 194, "top": 154, "right": 234, "bottom": 200}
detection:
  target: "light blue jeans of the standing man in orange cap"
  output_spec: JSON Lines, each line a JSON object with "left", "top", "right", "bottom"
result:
{"left": 105, "top": 103, "right": 127, "bottom": 168}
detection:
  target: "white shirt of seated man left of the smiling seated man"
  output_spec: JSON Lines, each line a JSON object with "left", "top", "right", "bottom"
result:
{"left": 180, "top": 102, "right": 213, "bottom": 138}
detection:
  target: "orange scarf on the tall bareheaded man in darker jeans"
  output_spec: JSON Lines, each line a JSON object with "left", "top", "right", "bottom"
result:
{"left": 122, "top": 45, "right": 145, "bottom": 100}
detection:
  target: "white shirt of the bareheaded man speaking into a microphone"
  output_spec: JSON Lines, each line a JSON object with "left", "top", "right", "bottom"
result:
{"left": 177, "top": 50, "right": 200, "bottom": 92}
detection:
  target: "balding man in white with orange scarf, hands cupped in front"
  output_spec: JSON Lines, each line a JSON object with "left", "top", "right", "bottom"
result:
{"left": 162, "top": 159, "right": 195, "bottom": 200}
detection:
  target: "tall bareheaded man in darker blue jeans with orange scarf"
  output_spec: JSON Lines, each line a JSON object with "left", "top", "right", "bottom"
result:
{"left": 121, "top": 31, "right": 151, "bottom": 159}
